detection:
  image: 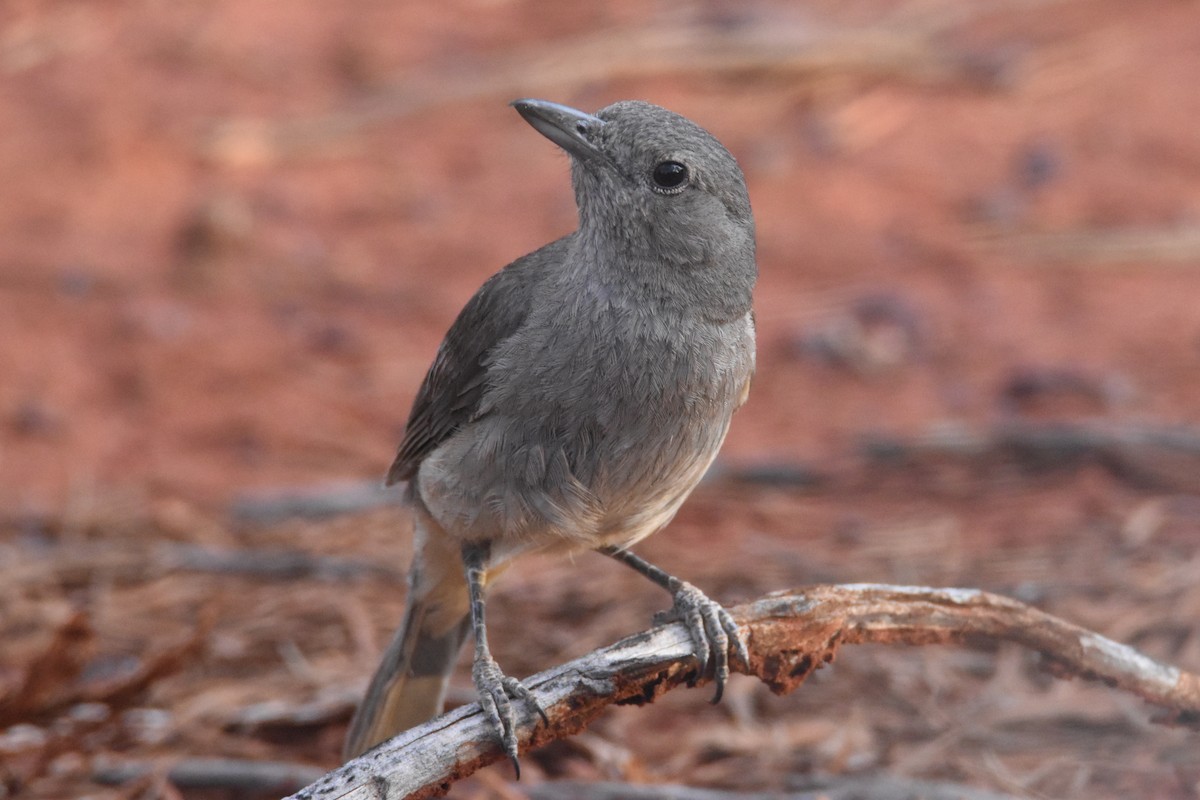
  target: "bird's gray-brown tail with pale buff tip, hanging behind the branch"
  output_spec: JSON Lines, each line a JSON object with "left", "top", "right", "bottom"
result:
{"left": 342, "top": 520, "right": 470, "bottom": 760}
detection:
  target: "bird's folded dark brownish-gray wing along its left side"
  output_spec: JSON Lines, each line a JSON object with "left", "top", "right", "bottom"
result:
{"left": 388, "top": 231, "right": 566, "bottom": 485}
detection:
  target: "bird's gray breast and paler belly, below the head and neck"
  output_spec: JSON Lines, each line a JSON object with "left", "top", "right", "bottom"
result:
{"left": 420, "top": 275, "right": 754, "bottom": 548}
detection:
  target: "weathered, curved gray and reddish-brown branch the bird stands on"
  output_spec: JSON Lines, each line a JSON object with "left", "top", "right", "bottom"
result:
{"left": 293, "top": 584, "right": 1200, "bottom": 800}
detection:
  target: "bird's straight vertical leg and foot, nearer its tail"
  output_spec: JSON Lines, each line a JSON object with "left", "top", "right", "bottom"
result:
{"left": 462, "top": 543, "right": 550, "bottom": 778}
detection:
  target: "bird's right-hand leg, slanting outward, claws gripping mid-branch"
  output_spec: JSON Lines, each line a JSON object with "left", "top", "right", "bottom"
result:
{"left": 600, "top": 547, "right": 750, "bottom": 703}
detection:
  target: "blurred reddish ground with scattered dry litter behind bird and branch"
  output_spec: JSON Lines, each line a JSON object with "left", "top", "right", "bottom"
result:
{"left": 0, "top": 0, "right": 1200, "bottom": 798}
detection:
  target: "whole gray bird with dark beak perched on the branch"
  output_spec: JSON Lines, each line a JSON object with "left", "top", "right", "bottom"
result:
{"left": 346, "top": 100, "right": 757, "bottom": 775}
